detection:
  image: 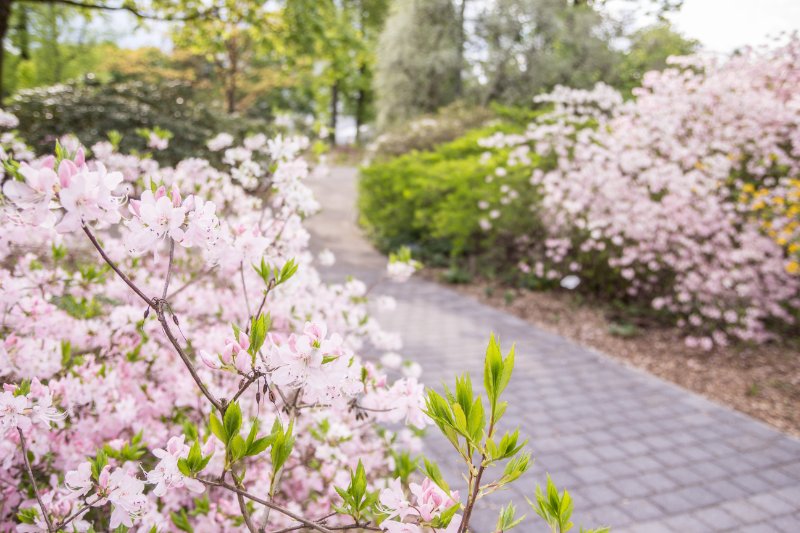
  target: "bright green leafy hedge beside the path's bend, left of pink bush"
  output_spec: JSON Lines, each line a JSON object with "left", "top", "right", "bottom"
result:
{"left": 359, "top": 123, "right": 543, "bottom": 270}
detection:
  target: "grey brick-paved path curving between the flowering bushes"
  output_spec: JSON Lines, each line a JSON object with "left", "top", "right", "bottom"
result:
{"left": 309, "top": 168, "right": 800, "bottom": 533}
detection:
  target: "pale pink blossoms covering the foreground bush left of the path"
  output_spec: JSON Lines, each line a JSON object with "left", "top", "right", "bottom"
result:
{"left": 0, "top": 122, "right": 432, "bottom": 531}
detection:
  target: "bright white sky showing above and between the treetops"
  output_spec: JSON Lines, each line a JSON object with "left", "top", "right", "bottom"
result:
{"left": 110, "top": 0, "right": 800, "bottom": 54}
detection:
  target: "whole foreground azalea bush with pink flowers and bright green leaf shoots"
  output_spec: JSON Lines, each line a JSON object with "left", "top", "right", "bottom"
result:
{"left": 0, "top": 109, "right": 608, "bottom": 533}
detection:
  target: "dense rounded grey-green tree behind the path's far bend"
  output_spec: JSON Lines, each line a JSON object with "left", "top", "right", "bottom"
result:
{"left": 375, "top": 0, "right": 461, "bottom": 129}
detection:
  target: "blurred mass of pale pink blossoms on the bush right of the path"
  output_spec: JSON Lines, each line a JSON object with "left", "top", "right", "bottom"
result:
{"left": 481, "top": 38, "right": 800, "bottom": 349}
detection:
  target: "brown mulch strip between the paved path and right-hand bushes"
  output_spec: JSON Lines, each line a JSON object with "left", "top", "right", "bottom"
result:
{"left": 422, "top": 269, "right": 800, "bottom": 436}
